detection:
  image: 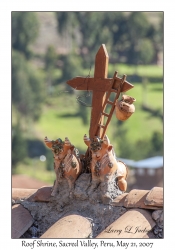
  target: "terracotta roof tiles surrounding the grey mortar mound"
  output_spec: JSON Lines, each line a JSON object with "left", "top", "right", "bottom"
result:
{"left": 12, "top": 187, "right": 163, "bottom": 238}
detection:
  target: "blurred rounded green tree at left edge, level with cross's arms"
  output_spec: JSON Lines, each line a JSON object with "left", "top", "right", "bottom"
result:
{"left": 12, "top": 51, "right": 44, "bottom": 120}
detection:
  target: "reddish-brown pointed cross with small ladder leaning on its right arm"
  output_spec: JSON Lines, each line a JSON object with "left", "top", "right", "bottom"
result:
{"left": 67, "top": 44, "right": 134, "bottom": 139}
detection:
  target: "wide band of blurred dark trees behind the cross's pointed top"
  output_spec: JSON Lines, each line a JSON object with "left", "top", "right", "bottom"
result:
{"left": 56, "top": 11, "right": 162, "bottom": 64}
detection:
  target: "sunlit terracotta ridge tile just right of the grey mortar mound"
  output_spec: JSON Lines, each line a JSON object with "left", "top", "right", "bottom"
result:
{"left": 124, "top": 189, "right": 159, "bottom": 209}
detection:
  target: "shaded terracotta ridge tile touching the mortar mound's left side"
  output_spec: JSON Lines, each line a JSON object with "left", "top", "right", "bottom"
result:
{"left": 28, "top": 187, "right": 52, "bottom": 202}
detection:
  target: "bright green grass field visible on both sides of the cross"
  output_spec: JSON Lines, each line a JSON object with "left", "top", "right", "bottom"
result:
{"left": 35, "top": 77, "right": 163, "bottom": 150}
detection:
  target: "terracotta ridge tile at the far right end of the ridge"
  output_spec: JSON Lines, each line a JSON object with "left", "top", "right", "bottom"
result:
{"left": 145, "top": 187, "right": 163, "bottom": 209}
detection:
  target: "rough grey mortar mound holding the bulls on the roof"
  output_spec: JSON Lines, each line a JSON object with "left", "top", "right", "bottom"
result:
{"left": 21, "top": 173, "right": 127, "bottom": 238}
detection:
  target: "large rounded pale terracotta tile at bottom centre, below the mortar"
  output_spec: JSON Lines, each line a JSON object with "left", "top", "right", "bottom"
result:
{"left": 40, "top": 215, "right": 92, "bottom": 239}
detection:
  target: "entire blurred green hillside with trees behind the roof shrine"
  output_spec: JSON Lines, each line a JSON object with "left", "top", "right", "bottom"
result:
{"left": 12, "top": 12, "right": 163, "bottom": 182}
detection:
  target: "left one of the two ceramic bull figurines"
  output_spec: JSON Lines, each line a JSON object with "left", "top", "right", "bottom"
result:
{"left": 44, "top": 136, "right": 82, "bottom": 197}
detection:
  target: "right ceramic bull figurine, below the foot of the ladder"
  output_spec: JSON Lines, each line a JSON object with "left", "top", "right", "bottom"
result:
{"left": 84, "top": 135, "right": 128, "bottom": 195}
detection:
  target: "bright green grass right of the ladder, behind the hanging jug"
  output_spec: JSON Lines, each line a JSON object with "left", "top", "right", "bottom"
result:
{"left": 114, "top": 83, "right": 163, "bottom": 142}
